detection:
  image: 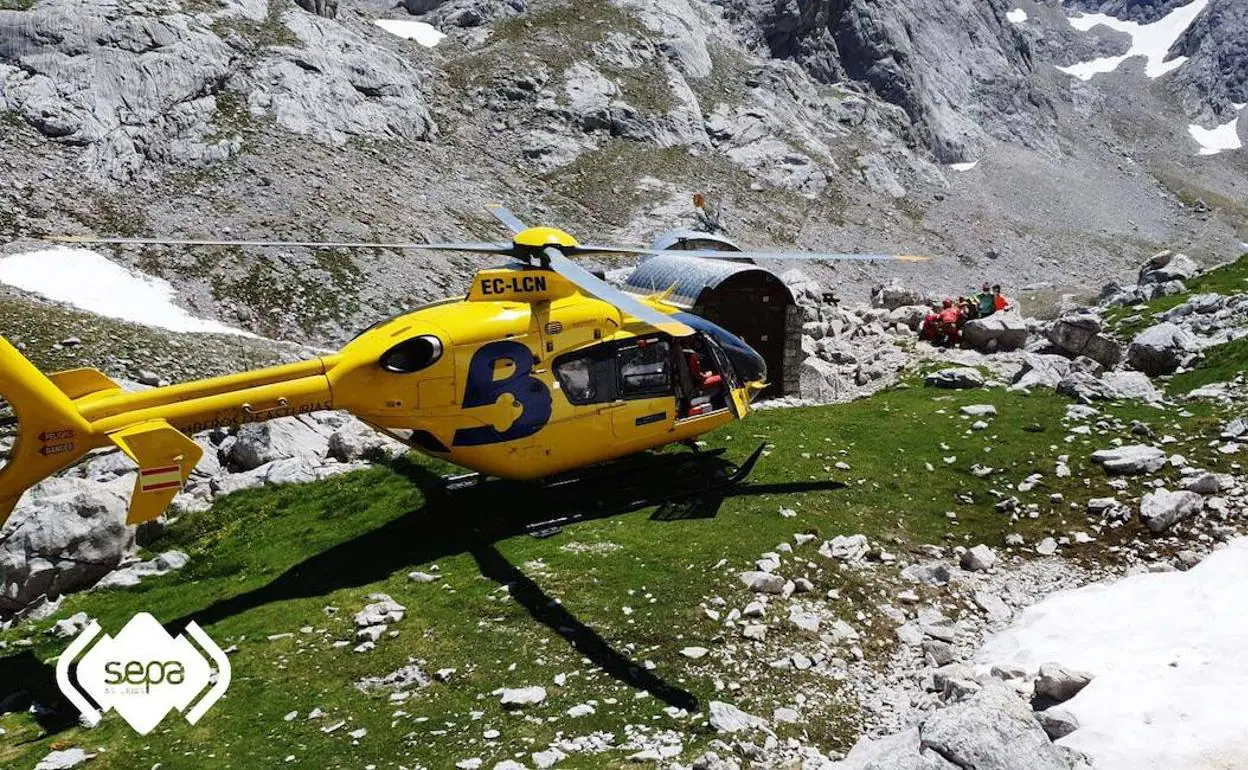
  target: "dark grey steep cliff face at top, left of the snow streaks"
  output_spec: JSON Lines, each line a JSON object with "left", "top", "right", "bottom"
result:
{"left": 725, "top": 0, "right": 1055, "bottom": 162}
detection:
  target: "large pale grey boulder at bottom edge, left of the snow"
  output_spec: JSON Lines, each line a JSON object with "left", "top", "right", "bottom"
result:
{"left": 920, "top": 685, "right": 1068, "bottom": 770}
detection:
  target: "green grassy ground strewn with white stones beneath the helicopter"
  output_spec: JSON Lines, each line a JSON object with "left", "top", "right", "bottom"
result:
{"left": 0, "top": 379, "right": 1229, "bottom": 769}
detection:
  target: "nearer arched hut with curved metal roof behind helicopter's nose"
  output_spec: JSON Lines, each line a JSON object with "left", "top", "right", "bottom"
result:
{"left": 625, "top": 251, "right": 802, "bottom": 398}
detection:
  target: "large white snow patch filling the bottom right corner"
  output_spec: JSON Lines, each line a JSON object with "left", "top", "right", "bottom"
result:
{"left": 975, "top": 538, "right": 1248, "bottom": 770}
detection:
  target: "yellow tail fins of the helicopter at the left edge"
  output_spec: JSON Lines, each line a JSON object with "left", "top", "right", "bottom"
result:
{"left": 0, "top": 337, "right": 203, "bottom": 525}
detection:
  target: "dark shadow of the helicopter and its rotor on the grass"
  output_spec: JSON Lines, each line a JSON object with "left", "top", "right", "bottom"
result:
{"left": 0, "top": 452, "right": 844, "bottom": 731}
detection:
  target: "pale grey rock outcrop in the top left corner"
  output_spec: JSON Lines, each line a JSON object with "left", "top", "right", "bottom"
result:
{"left": 0, "top": 1, "right": 236, "bottom": 178}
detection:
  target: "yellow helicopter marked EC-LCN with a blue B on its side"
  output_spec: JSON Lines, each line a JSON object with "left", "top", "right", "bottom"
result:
{"left": 0, "top": 206, "right": 926, "bottom": 525}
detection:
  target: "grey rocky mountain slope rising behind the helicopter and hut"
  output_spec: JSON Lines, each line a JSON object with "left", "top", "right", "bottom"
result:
{"left": 0, "top": 0, "right": 1248, "bottom": 343}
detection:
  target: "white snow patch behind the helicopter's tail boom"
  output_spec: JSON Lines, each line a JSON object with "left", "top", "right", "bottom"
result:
{"left": 0, "top": 246, "right": 255, "bottom": 337}
